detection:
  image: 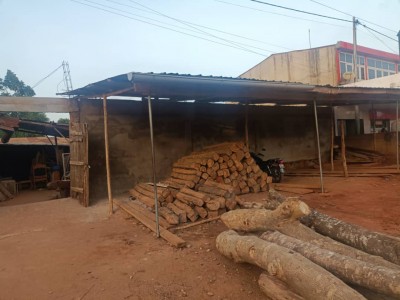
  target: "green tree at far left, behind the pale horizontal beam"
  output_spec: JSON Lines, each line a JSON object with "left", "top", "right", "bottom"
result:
{"left": 0, "top": 70, "right": 49, "bottom": 122}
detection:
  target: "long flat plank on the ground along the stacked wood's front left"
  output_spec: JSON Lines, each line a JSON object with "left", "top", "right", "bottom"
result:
{"left": 114, "top": 199, "right": 186, "bottom": 248}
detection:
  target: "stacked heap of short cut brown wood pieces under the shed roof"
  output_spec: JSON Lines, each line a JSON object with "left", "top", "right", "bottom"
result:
{"left": 130, "top": 143, "right": 271, "bottom": 225}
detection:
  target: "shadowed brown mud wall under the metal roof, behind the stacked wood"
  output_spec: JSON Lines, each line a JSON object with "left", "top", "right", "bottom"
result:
{"left": 79, "top": 100, "right": 330, "bottom": 199}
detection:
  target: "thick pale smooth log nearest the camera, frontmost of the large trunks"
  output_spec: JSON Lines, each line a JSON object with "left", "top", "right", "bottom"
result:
{"left": 216, "top": 230, "right": 365, "bottom": 300}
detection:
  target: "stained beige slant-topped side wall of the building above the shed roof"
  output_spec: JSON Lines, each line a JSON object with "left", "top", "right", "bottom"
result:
{"left": 240, "top": 45, "right": 338, "bottom": 86}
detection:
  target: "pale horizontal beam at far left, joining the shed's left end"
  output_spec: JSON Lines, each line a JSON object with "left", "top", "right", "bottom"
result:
{"left": 0, "top": 96, "right": 79, "bottom": 113}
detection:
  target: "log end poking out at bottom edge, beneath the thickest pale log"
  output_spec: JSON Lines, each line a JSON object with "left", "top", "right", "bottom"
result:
{"left": 258, "top": 273, "right": 304, "bottom": 300}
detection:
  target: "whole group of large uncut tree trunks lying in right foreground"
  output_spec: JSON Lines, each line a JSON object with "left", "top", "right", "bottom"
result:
{"left": 216, "top": 190, "right": 400, "bottom": 299}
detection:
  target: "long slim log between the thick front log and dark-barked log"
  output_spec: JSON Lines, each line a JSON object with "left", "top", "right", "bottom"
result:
{"left": 261, "top": 231, "right": 400, "bottom": 298}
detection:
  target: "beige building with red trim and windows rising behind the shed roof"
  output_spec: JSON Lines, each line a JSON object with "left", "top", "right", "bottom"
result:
{"left": 240, "top": 42, "right": 400, "bottom": 86}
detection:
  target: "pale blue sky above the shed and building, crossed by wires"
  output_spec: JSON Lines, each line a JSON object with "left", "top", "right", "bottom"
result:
{"left": 0, "top": 0, "right": 400, "bottom": 113}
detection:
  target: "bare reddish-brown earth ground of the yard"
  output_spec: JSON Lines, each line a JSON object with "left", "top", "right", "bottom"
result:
{"left": 0, "top": 176, "right": 400, "bottom": 299}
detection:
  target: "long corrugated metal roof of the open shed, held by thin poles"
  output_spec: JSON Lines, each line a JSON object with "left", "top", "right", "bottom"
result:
{"left": 58, "top": 72, "right": 400, "bottom": 105}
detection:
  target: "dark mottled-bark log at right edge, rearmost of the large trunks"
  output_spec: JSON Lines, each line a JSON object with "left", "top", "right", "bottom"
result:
{"left": 305, "top": 210, "right": 400, "bottom": 265}
